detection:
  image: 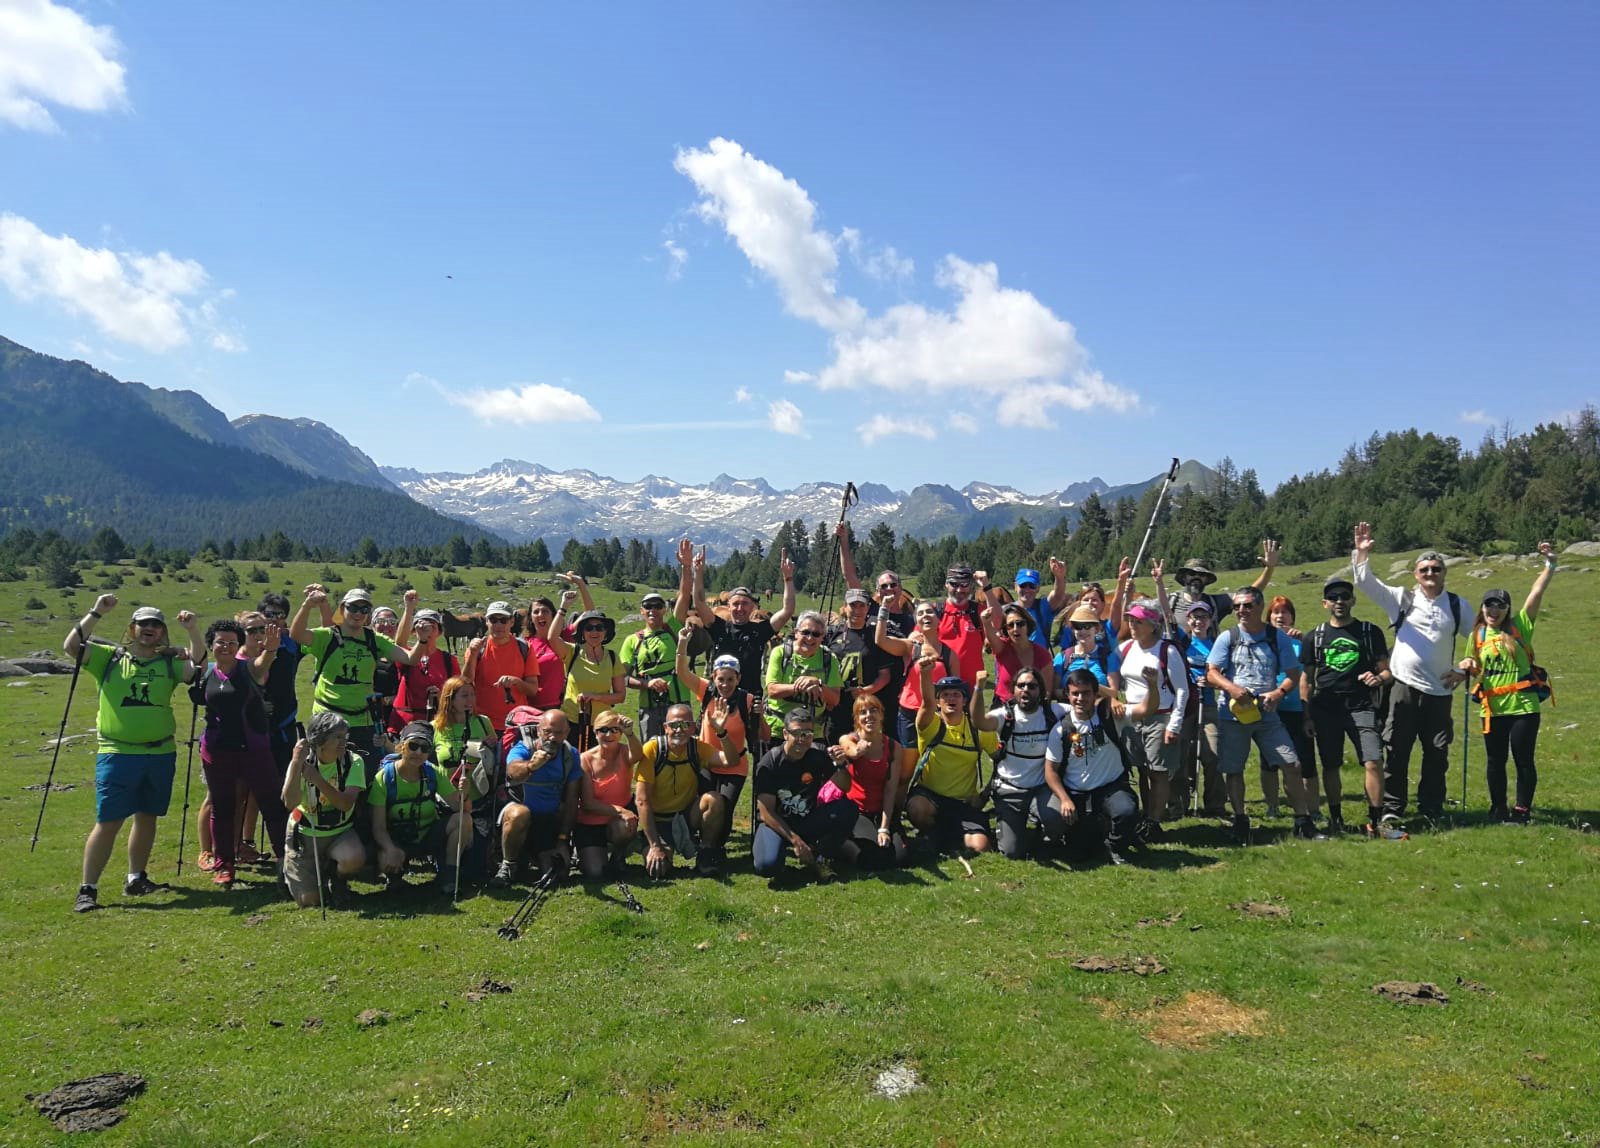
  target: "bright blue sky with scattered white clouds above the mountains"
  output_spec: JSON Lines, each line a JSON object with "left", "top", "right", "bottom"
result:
{"left": 0, "top": 0, "right": 1600, "bottom": 491}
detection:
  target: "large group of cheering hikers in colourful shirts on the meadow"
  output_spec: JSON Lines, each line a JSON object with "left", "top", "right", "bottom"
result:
{"left": 64, "top": 523, "right": 1555, "bottom": 911}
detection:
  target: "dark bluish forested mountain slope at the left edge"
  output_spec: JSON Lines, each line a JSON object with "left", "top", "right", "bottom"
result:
{"left": 0, "top": 337, "right": 485, "bottom": 547}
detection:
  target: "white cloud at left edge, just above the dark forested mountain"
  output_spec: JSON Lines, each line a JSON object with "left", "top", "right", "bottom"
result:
{"left": 0, "top": 214, "right": 229, "bottom": 352}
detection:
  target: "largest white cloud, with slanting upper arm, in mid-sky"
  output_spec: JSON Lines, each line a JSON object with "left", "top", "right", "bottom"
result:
{"left": 675, "top": 138, "right": 1139, "bottom": 427}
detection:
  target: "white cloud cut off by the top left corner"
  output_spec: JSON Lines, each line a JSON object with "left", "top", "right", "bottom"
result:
{"left": 0, "top": 0, "right": 128, "bottom": 131}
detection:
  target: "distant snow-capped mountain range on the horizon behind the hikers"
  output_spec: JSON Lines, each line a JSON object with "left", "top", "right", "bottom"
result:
{"left": 382, "top": 459, "right": 1190, "bottom": 553}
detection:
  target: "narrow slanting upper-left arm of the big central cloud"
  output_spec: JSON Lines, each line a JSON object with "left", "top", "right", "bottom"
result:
{"left": 672, "top": 138, "right": 864, "bottom": 331}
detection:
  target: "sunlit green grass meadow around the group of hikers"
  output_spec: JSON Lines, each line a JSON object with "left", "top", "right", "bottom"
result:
{"left": 0, "top": 558, "right": 1600, "bottom": 1145}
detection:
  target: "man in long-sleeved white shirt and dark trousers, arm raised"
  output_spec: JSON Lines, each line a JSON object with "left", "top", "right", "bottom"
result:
{"left": 1350, "top": 523, "right": 1472, "bottom": 825}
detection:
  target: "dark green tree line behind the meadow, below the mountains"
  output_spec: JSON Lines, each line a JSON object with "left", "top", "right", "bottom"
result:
{"left": 0, "top": 406, "right": 1600, "bottom": 593}
